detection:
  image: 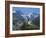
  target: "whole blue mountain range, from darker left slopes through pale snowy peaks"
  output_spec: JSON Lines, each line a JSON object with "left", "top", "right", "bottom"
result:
{"left": 13, "top": 11, "right": 39, "bottom": 20}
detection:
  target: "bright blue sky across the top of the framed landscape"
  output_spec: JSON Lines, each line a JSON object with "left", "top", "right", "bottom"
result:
{"left": 13, "top": 7, "right": 40, "bottom": 14}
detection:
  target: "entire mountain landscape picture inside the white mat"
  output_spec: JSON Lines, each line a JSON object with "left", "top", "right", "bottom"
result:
{"left": 12, "top": 7, "right": 40, "bottom": 30}
